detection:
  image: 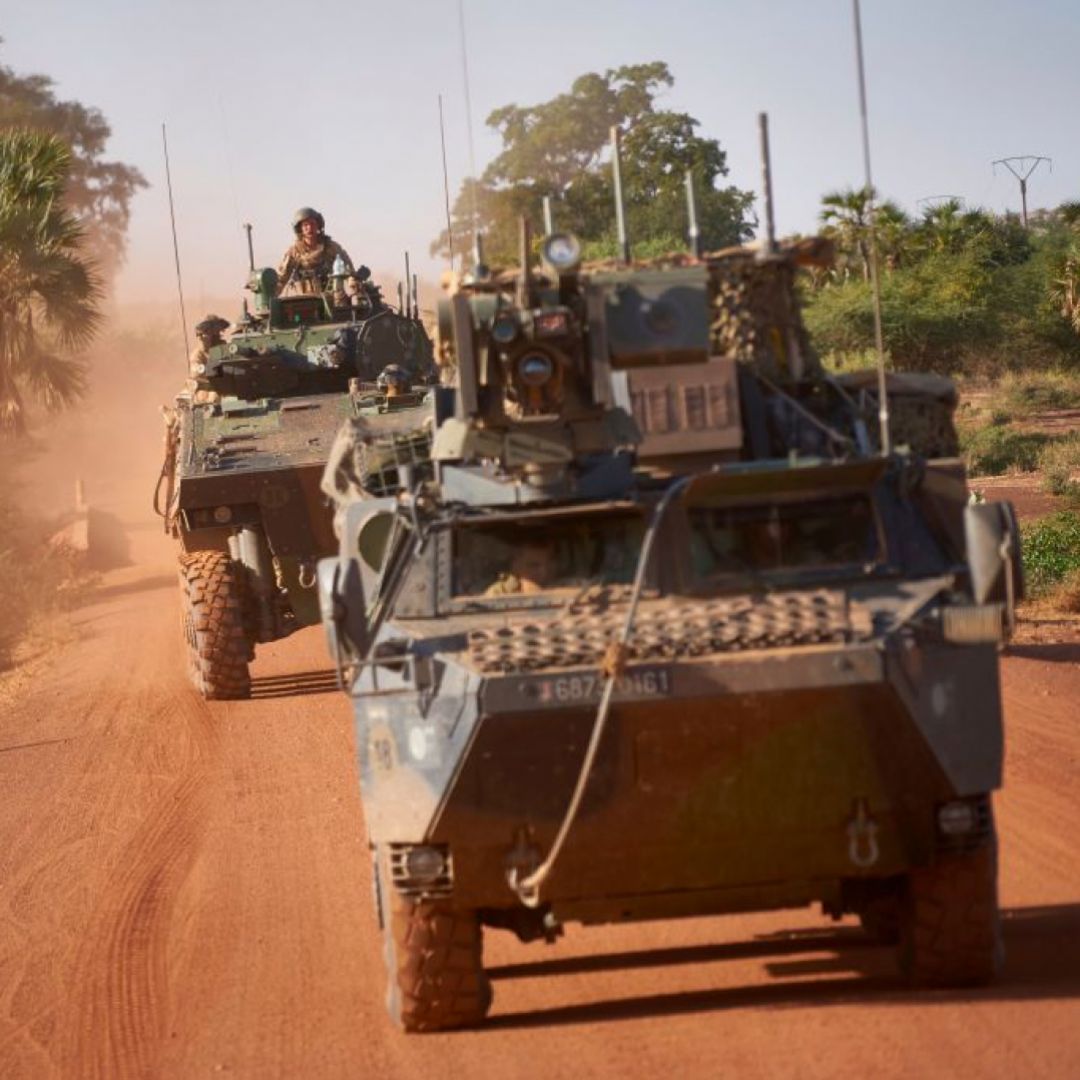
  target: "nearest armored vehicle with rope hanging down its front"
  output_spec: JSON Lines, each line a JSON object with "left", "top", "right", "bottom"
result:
{"left": 319, "top": 217, "right": 1022, "bottom": 1031}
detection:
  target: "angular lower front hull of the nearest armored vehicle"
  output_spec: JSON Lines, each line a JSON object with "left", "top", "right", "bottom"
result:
{"left": 357, "top": 644, "right": 1001, "bottom": 922}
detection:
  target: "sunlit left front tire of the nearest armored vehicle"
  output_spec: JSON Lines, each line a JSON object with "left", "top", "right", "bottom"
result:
{"left": 382, "top": 889, "right": 491, "bottom": 1031}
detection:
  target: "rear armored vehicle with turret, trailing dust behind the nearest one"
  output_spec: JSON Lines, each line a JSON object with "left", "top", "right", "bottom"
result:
{"left": 158, "top": 261, "right": 435, "bottom": 698}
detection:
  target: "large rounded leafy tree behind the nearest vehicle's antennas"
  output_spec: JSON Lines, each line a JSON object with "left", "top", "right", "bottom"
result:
{"left": 432, "top": 60, "right": 753, "bottom": 264}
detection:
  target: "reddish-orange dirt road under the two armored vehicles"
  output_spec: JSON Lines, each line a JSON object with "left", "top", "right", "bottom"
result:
{"left": 0, "top": 523, "right": 1080, "bottom": 1080}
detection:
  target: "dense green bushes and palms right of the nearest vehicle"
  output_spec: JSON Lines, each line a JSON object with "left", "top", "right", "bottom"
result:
{"left": 805, "top": 200, "right": 1080, "bottom": 372}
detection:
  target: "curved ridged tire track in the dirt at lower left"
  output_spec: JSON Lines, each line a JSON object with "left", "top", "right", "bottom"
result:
{"left": 70, "top": 693, "right": 216, "bottom": 1080}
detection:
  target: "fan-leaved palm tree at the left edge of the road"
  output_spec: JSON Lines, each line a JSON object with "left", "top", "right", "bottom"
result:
{"left": 0, "top": 130, "right": 102, "bottom": 434}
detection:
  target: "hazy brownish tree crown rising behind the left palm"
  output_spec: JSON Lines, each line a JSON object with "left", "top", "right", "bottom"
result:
{"left": 0, "top": 39, "right": 147, "bottom": 276}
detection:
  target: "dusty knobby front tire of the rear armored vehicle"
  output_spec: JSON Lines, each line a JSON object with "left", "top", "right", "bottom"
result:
{"left": 180, "top": 551, "right": 252, "bottom": 700}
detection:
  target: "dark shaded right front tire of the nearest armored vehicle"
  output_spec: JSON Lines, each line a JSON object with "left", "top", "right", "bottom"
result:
{"left": 900, "top": 841, "right": 1004, "bottom": 986}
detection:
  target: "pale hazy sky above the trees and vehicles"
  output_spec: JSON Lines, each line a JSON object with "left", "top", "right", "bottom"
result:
{"left": 0, "top": 0, "right": 1080, "bottom": 310}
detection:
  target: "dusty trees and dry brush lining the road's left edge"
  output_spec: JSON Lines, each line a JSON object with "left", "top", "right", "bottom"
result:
{"left": 0, "top": 54, "right": 146, "bottom": 670}
